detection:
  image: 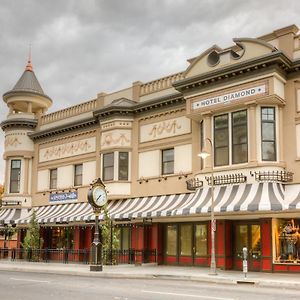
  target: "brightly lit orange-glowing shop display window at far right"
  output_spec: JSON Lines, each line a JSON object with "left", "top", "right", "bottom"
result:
{"left": 274, "top": 219, "right": 300, "bottom": 263}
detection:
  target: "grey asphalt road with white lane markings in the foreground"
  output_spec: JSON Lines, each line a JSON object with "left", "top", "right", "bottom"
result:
{"left": 0, "top": 271, "right": 300, "bottom": 300}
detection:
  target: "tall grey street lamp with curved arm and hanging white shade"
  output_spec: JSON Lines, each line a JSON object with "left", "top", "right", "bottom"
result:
{"left": 198, "top": 138, "right": 217, "bottom": 275}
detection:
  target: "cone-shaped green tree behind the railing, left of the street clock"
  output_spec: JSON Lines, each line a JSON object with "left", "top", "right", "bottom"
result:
{"left": 21, "top": 211, "right": 44, "bottom": 250}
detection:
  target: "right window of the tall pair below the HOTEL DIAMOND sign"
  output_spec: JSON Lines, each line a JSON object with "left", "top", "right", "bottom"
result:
{"left": 231, "top": 110, "right": 248, "bottom": 164}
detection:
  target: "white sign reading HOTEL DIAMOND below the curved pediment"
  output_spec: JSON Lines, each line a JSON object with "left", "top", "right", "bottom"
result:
{"left": 192, "top": 85, "right": 266, "bottom": 109}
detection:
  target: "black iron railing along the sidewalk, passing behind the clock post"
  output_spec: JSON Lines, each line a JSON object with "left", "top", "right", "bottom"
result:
{"left": 0, "top": 248, "right": 157, "bottom": 265}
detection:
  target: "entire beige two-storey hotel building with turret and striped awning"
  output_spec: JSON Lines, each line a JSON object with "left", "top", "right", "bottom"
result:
{"left": 0, "top": 25, "right": 300, "bottom": 272}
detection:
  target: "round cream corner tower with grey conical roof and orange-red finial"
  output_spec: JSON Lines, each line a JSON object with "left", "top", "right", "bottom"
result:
{"left": 0, "top": 55, "right": 52, "bottom": 207}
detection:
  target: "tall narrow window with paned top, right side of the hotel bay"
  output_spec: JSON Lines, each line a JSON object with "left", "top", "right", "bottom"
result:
{"left": 261, "top": 107, "right": 276, "bottom": 161}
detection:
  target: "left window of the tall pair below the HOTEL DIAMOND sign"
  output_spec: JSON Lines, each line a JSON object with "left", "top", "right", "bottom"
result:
{"left": 214, "top": 114, "right": 229, "bottom": 166}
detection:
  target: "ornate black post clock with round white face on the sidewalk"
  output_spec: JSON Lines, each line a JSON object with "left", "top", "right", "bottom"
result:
{"left": 87, "top": 178, "right": 107, "bottom": 271}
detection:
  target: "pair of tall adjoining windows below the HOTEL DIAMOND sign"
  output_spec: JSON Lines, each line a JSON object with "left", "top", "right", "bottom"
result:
{"left": 214, "top": 110, "right": 248, "bottom": 166}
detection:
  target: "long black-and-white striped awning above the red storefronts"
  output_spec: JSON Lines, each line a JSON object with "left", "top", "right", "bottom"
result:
{"left": 8, "top": 182, "right": 300, "bottom": 224}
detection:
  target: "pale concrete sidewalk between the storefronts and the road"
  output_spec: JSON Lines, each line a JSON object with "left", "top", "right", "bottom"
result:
{"left": 0, "top": 260, "right": 300, "bottom": 290}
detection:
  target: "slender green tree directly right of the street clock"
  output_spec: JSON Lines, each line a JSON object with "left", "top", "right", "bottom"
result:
{"left": 100, "top": 206, "right": 120, "bottom": 264}
